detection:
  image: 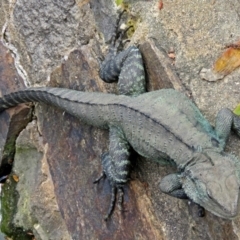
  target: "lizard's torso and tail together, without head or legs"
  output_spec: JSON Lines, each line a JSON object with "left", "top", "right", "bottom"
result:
{"left": 0, "top": 88, "right": 218, "bottom": 166}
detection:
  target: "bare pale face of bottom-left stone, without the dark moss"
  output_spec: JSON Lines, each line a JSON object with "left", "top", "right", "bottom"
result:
{"left": 12, "top": 121, "right": 71, "bottom": 240}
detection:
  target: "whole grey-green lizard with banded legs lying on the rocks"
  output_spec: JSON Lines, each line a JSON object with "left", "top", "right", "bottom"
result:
{"left": 0, "top": 11, "right": 240, "bottom": 219}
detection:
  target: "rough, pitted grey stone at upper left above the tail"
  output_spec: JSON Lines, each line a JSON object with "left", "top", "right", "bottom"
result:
{"left": 3, "top": 0, "right": 94, "bottom": 85}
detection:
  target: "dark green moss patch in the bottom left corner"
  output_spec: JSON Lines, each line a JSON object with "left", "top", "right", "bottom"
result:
{"left": 1, "top": 176, "right": 33, "bottom": 240}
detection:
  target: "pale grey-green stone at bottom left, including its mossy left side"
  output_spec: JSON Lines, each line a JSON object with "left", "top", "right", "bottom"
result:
{"left": 2, "top": 121, "right": 71, "bottom": 240}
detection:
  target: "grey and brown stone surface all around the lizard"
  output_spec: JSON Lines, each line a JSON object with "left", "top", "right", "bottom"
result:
{"left": 0, "top": 0, "right": 240, "bottom": 240}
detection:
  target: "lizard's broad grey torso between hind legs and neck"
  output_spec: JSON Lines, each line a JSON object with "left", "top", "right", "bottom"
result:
{"left": 115, "top": 89, "right": 218, "bottom": 166}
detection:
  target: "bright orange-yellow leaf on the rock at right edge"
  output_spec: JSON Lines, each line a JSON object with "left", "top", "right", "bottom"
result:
{"left": 214, "top": 41, "right": 240, "bottom": 75}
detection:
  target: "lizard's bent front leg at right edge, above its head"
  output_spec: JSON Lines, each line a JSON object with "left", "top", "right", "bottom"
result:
{"left": 215, "top": 108, "right": 240, "bottom": 149}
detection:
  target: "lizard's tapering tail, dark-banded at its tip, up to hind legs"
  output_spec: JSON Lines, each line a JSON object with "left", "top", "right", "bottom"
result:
{"left": 0, "top": 87, "right": 125, "bottom": 127}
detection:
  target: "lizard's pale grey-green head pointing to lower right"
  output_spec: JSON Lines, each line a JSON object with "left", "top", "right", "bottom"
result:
{"left": 182, "top": 151, "right": 240, "bottom": 219}
